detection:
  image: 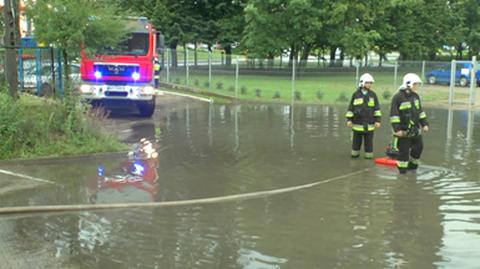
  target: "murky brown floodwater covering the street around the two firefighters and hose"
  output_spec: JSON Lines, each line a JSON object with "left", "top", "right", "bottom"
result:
{"left": 0, "top": 95, "right": 480, "bottom": 269}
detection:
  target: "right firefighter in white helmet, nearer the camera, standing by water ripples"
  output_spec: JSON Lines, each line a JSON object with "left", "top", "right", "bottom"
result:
{"left": 390, "top": 73, "right": 428, "bottom": 174}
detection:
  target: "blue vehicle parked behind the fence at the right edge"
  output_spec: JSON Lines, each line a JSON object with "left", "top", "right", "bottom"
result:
{"left": 425, "top": 62, "right": 480, "bottom": 87}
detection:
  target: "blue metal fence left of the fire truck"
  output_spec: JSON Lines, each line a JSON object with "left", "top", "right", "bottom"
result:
{"left": 0, "top": 47, "right": 69, "bottom": 96}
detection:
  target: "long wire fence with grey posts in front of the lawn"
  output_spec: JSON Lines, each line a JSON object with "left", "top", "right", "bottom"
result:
{"left": 161, "top": 49, "right": 478, "bottom": 104}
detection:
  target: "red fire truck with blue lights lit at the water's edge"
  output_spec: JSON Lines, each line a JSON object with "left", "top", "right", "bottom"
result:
{"left": 80, "top": 17, "right": 163, "bottom": 117}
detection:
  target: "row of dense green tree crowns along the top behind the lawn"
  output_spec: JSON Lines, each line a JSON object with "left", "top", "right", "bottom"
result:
{"left": 115, "top": 0, "right": 480, "bottom": 61}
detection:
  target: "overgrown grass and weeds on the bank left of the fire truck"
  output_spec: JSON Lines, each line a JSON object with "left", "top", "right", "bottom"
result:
{"left": 0, "top": 93, "right": 124, "bottom": 159}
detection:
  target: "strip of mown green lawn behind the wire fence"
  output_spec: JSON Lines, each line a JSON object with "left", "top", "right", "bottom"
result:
{"left": 166, "top": 73, "right": 462, "bottom": 104}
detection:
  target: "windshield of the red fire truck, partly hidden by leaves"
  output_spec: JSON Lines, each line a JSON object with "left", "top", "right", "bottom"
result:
{"left": 96, "top": 33, "right": 149, "bottom": 56}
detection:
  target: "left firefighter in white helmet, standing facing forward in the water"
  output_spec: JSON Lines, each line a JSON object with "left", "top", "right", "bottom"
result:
{"left": 346, "top": 73, "right": 382, "bottom": 159}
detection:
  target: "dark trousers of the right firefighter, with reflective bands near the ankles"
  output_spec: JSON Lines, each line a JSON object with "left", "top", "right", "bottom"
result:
{"left": 397, "top": 135, "right": 423, "bottom": 172}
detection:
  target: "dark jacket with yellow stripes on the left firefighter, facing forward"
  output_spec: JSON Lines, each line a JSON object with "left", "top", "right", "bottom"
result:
{"left": 345, "top": 88, "right": 382, "bottom": 132}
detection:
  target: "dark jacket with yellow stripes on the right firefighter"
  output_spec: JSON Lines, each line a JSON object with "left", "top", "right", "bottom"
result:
{"left": 390, "top": 89, "right": 428, "bottom": 137}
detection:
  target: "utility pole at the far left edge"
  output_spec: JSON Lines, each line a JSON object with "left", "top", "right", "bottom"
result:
{"left": 3, "top": 0, "right": 20, "bottom": 99}
